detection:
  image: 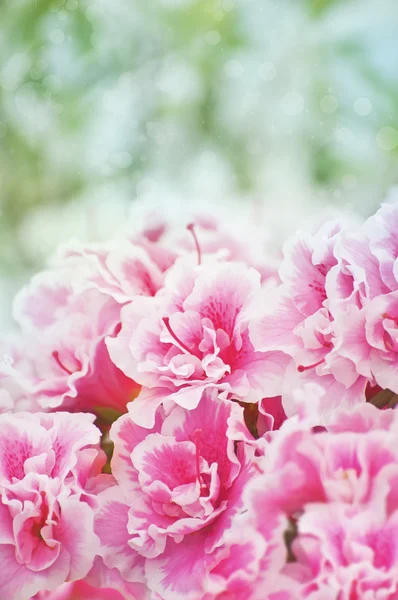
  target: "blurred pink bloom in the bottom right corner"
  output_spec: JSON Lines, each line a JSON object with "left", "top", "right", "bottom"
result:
{"left": 284, "top": 504, "right": 398, "bottom": 600}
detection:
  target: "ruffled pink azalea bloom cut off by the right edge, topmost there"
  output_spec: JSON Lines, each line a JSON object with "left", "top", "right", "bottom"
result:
{"left": 329, "top": 204, "right": 398, "bottom": 398}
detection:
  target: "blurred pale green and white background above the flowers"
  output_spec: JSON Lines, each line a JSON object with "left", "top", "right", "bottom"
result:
{"left": 0, "top": 0, "right": 398, "bottom": 322}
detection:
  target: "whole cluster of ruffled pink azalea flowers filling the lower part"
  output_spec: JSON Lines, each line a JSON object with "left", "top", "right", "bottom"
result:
{"left": 0, "top": 204, "right": 398, "bottom": 600}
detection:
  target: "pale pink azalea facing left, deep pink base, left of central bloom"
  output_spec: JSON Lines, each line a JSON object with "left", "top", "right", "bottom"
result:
{"left": 14, "top": 271, "right": 138, "bottom": 412}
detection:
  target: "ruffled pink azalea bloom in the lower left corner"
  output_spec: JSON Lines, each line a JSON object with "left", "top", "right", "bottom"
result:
{"left": 0, "top": 413, "right": 108, "bottom": 600}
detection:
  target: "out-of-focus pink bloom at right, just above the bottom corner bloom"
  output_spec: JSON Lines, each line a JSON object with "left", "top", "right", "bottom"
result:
{"left": 252, "top": 405, "right": 398, "bottom": 516}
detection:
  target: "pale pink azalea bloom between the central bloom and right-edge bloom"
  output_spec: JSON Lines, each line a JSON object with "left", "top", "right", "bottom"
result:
{"left": 249, "top": 222, "right": 367, "bottom": 422}
